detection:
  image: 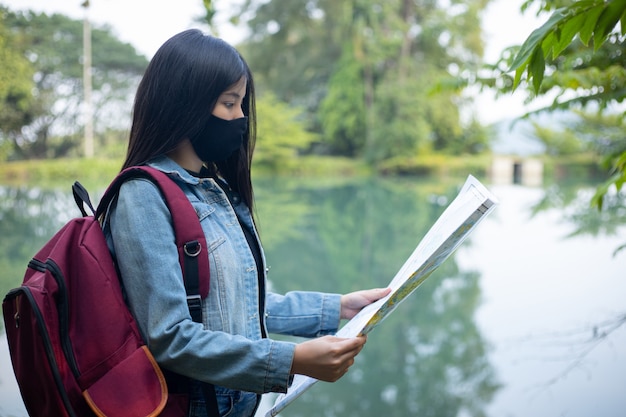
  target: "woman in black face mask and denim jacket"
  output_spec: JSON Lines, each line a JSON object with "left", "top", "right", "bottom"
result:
{"left": 105, "top": 30, "right": 388, "bottom": 416}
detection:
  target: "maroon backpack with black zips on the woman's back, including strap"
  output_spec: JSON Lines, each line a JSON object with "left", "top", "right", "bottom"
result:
{"left": 2, "top": 166, "right": 216, "bottom": 417}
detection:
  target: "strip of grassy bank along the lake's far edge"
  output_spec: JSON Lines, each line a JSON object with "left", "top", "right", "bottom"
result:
{"left": 0, "top": 155, "right": 597, "bottom": 187}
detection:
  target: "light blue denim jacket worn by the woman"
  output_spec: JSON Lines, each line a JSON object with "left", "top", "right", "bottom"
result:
{"left": 104, "top": 157, "right": 340, "bottom": 412}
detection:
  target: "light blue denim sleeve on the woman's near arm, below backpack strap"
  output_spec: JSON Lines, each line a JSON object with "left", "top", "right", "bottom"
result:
{"left": 109, "top": 179, "right": 295, "bottom": 393}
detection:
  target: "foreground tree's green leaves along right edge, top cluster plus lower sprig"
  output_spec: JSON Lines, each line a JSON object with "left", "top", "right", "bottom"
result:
{"left": 502, "top": 0, "right": 626, "bottom": 254}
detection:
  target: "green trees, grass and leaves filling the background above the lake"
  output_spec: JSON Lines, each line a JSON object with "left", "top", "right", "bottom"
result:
{"left": 0, "top": 0, "right": 626, "bottom": 197}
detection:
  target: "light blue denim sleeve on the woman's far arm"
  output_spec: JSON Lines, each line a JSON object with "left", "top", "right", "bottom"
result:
{"left": 265, "top": 291, "right": 341, "bottom": 337}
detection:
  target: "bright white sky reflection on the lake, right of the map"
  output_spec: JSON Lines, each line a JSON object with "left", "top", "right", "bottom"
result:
{"left": 456, "top": 186, "right": 626, "bottom": 417}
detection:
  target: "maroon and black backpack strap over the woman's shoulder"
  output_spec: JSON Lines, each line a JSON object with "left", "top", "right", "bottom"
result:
{"left": 94, "top": 166, "right": 220, "bottom": 417}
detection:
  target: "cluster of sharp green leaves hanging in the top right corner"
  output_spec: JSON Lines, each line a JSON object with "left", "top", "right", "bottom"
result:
{"left": 481, "top": 0, "right": 626, "bottom": 111}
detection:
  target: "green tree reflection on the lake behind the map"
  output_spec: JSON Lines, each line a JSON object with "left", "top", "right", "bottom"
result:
{"left": 251, "top": 179, "right": 498, "bottom": 416}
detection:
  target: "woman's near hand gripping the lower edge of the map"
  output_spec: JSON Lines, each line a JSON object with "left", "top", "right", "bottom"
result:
{"left": 291, "top": 336, "right": 366, "bottom": 382}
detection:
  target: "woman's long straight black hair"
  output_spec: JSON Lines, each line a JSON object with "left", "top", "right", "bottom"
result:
{"left": 122, "top": 29, "right": 256, "bottom": 210}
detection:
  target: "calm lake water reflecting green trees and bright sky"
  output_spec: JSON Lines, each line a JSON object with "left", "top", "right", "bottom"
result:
{"left": 0, "top": 174, "right": 626, "bottom": 417}
